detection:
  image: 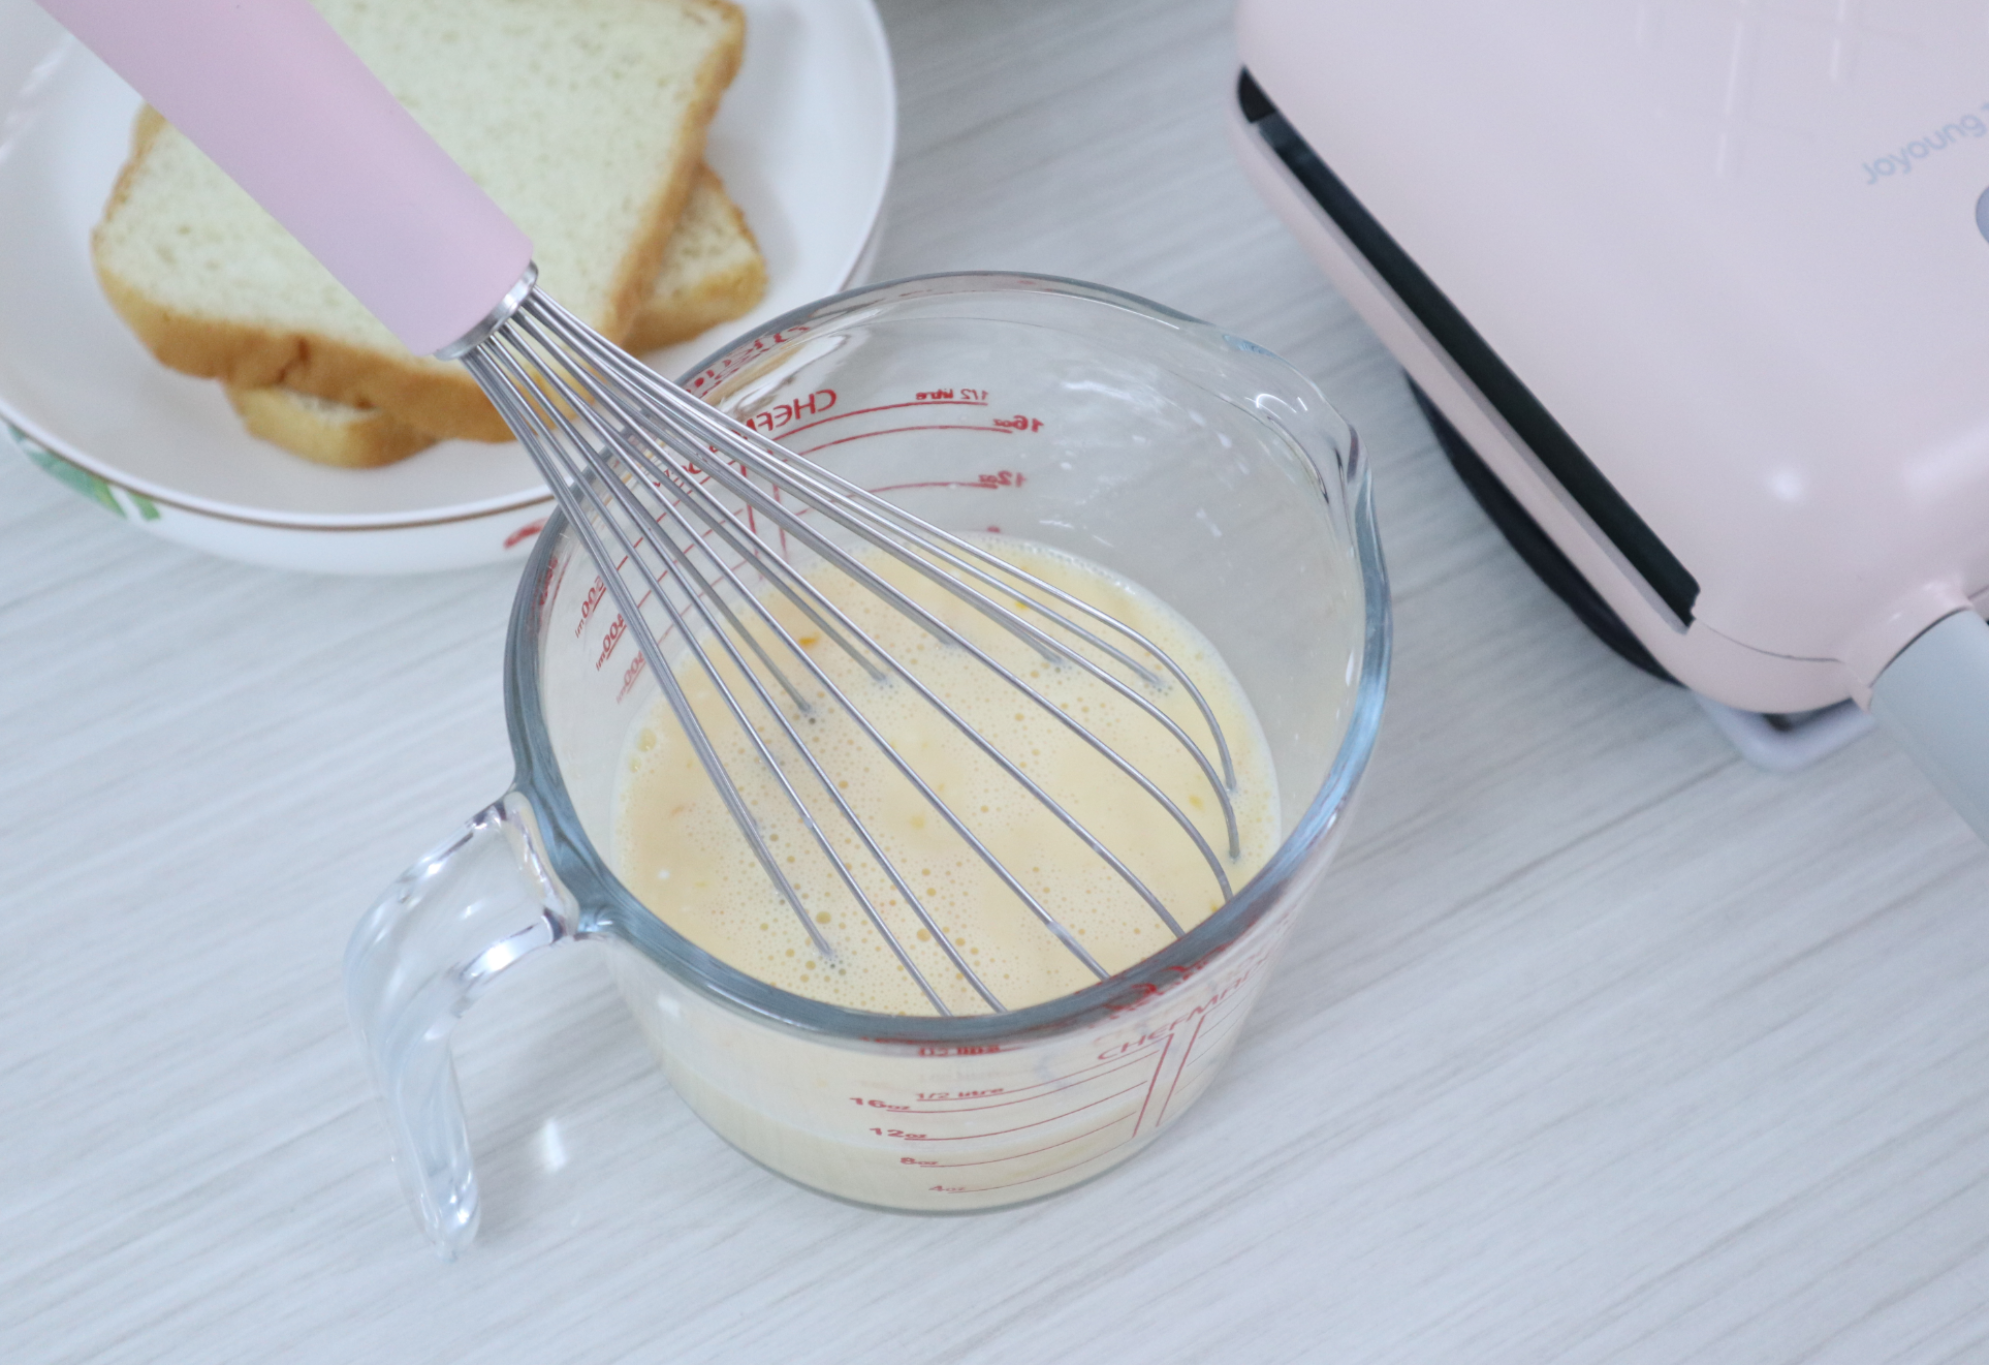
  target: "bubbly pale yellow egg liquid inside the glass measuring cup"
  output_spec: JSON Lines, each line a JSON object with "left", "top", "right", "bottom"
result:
{"left": 615, "top": 537, "right": 1279, "bottom": 1015}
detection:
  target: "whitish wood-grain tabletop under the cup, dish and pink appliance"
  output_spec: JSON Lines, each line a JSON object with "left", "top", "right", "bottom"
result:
{"left": 0, "top": 0, "right": 1989, "bottom": 1365}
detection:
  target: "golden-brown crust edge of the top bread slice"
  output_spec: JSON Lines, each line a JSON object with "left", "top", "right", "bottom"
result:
{"left": 91, "top": 0, "right": 746, "bottom": 442}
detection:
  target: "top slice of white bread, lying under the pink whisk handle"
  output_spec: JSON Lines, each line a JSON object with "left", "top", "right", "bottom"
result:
{"left": 91, "top": 0, "right": 744, "bottom": 440}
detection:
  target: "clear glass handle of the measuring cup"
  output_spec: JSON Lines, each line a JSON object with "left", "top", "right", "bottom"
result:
{"left": 346, "top": 792, "right": 579, "bottom": 1262}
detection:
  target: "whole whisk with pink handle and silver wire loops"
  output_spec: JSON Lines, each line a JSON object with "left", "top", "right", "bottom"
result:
{"left": 48, "top": 0, "right": 1239, "bottom": 1015}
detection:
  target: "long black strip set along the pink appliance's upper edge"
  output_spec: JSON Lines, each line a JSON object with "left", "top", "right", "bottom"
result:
{"left": 1237, "top": 70, "right": 1699, "bottom": 623}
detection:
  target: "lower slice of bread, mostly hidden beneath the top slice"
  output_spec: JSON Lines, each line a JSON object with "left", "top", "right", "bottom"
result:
{"left": 228, "top": 162, "right": 766, "bottom": 470}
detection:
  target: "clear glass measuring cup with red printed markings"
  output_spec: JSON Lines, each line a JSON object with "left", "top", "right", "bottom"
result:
{"left": 346, "top": 275, "right": 1388, "bottom": 1256}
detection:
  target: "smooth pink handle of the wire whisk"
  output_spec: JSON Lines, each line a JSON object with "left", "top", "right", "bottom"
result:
{"left": 42, "top": 0, "right": 531, "bottom": 354}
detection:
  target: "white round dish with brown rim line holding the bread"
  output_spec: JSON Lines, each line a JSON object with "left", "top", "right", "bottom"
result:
{"left": 0, "top": 0, "right": 897, "bottom": 573}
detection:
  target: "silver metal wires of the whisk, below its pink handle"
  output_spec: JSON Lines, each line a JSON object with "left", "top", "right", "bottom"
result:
{"left": 461, "top": 287, "right": 1239, "bottom": 1015}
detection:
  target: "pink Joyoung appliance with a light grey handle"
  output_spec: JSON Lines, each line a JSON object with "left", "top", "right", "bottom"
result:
{"left": 1231, "top": 0, "right": 1989, "bottom": 838}
